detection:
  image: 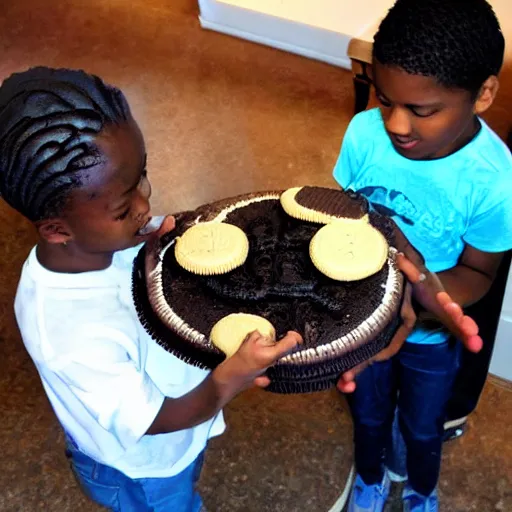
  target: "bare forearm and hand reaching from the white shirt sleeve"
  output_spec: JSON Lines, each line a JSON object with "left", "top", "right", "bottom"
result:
{"left": 146, "top": 332, "right": 302, "bottom": 435}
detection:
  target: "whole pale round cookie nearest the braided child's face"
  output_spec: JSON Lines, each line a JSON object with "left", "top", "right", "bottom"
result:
{"left": 174, "top": 222, "right": 249, "bottom": 275}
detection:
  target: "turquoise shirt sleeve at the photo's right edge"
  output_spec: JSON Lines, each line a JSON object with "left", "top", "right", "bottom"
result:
{"left": 464, "top": 176, "right": 512, "bottom": 252}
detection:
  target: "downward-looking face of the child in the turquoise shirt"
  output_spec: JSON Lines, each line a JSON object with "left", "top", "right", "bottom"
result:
{"left": 373, "top": 62, "right": 478, "bottom": 160}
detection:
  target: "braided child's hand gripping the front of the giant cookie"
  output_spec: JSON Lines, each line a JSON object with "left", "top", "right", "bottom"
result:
{"left": 214, "top": 331, "right": 302, "bottom": 394}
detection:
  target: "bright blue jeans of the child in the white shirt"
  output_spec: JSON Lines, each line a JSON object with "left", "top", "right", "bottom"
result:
{"left": 66, "top": 441, "right": 203, "bottom": 512}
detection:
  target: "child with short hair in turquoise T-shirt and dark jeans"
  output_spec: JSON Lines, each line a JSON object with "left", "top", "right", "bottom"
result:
{"left": 334, "top": 0, "right": 512, "bottom": 512}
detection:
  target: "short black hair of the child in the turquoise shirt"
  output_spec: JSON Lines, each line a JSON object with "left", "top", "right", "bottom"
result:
{"left": 373, "top": 0, "right": 505, "bottom": 95}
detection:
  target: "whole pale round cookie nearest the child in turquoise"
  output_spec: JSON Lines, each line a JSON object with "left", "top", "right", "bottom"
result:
{"left": 309, "top": 220, "right": 389, "bottom": 281}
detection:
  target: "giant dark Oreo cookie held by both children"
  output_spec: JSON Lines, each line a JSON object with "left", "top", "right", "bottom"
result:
{"left": 133, "top": 187, "right": 403, "bottom": 393}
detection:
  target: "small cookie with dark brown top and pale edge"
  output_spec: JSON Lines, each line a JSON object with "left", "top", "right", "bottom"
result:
{"left": 280, "top": 187, "right": 368, "bottom": 224}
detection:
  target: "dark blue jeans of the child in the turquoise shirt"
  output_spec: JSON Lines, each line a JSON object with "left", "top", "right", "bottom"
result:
{"left": 348, "top": 341, "right": 461, "bottom": 496}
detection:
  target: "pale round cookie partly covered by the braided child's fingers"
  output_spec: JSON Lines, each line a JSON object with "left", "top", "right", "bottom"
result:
{"left": 210, "top": 313, "right": 276, "bottom": 357}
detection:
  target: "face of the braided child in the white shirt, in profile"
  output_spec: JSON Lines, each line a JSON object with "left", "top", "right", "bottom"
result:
{"left": 58, "top": 120, "right": 151, "bottom": 253}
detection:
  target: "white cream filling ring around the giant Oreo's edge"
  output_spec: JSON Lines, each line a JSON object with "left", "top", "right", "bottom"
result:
{"left": 147, "top": 193, "right": 403, "bottom": 365}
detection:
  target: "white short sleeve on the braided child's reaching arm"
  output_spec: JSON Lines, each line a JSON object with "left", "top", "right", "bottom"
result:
{"left": 55, "top": 326, "right": 165, "bottom": 449}
